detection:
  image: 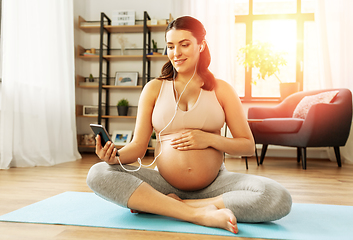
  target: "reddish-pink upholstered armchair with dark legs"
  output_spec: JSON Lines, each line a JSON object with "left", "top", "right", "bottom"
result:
{"left": 248, "top": 89, "right": 352, "bottom": 169}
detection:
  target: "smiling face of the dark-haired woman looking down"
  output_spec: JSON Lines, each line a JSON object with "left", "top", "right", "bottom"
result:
{"left": 166, "top": 29, "right": 201, "bottom": 74}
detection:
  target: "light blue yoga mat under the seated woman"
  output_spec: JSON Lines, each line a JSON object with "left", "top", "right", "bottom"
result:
{"left": 0, "top": 192, "right": 353, "bottom": 240}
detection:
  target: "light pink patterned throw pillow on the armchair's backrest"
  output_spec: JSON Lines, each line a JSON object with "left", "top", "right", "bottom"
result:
{"left": 293, "top": 91, "right": 339, "bottom": 119}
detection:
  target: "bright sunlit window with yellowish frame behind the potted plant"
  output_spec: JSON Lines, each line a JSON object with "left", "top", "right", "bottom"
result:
{"left": 234, "top": 0, "right": 318, "bottom": 101}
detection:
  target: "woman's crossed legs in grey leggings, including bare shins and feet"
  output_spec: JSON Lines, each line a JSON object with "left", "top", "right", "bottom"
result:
{"left": 87, "top": 162, "right": 291, "bottom": 233}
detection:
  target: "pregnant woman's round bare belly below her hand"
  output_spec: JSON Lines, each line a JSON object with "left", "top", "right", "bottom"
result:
{"left": 156, "top": 134, "right": 223, "bottom": 191}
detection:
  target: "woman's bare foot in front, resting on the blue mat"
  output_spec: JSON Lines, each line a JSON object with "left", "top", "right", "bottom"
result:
{"left": 194, "top": 205, "right": 238, "bottom": 233}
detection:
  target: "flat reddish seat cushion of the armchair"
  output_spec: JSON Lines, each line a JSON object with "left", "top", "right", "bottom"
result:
{"left": 256, "top": 118, "right": 304, "bottom": 133}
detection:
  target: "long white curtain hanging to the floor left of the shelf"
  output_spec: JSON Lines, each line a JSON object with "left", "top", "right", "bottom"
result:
{"left": 0, "top": 0, "right": 81, "bottom": 169}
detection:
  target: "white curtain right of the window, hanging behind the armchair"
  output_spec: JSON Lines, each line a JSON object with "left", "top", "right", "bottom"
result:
{"left": 315, "top": 0, "right": 353, "bottom": 163}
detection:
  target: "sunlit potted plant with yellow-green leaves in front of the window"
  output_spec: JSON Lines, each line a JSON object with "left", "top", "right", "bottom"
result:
{"left": 238, "top": 41, "right": 299, "bottom": 99}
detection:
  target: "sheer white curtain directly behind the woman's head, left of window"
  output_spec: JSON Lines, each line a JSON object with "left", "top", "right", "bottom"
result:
{"left": 173, "top": 0, "right": 237, "bottom": 86}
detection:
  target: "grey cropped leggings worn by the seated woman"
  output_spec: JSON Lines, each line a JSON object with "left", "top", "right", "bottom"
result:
{"left": 87, "top": 162, "right": 292, "bottom": 222}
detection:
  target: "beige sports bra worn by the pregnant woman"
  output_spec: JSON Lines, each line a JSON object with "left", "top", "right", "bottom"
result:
{"left": 152, "top": 80, "right": 225, "bottom": 137}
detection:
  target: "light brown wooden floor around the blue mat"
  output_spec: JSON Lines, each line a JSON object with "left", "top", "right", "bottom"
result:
{"left": 0, "top": 153, "right": 353, "bottom": 240}
